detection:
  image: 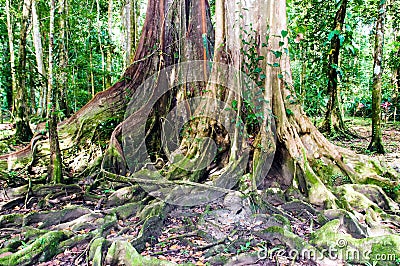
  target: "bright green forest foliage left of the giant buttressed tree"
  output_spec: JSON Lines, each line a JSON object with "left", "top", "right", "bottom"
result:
{"left": 1, "top": 0, "right": 145, "bottom": 122}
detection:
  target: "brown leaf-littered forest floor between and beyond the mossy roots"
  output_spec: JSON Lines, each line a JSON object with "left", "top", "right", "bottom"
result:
{"left": 0, "top": 118, "right": 400, "bottom": 266}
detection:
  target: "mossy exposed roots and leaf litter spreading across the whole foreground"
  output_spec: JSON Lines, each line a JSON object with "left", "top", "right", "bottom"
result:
{"left": 0, "top": 176, "right": 400, "bottom": 265}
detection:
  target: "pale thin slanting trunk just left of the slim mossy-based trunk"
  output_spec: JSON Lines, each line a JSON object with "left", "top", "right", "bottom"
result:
{"left": 32, "top": 0, "right": 47, "bottom": 117}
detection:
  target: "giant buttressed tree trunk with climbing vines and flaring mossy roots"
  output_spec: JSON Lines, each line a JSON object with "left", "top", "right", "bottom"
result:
{"left": 0, "top": 0, "right": 400, "bottom": 265}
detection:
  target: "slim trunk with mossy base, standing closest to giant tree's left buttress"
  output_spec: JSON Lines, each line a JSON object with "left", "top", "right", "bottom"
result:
{"left": 47, "top": 0, "right": 63, "bottom": 183}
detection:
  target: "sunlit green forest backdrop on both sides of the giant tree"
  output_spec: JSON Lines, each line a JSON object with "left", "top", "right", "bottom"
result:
{"left": 0, "top": 0, "right": 399, "bottom": 130}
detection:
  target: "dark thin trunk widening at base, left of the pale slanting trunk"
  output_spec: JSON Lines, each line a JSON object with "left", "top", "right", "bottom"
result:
{"left": 14, "top": 0, "right": 33, "bottom": 141}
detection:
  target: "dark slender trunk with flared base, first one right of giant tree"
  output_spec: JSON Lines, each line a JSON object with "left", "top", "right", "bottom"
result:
{"left": 321, "top": 0, "right": 348, "bottom": 134}
